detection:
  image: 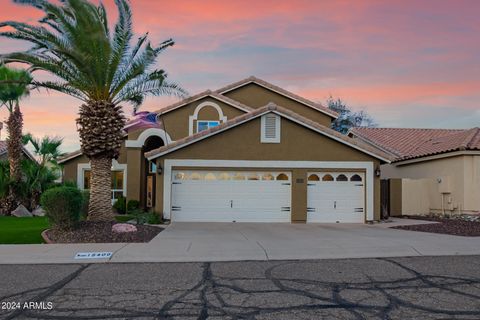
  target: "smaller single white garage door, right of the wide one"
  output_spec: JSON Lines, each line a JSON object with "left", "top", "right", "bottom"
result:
{"left": 307, "top": 172, "right": 365, "bottom": 223}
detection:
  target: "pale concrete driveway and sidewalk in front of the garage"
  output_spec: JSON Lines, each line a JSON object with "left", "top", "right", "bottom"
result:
{"left": 0, "top": 219, "right": 480, "bottom": 264}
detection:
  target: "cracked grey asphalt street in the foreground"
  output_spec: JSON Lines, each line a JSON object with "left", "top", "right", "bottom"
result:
{"left": 0, "top": 256, "right": 480, "bottom": 320}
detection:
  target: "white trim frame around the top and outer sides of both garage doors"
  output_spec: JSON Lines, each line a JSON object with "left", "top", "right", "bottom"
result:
{"left": 163, "top": 159, "right": 375, "bottom": 221}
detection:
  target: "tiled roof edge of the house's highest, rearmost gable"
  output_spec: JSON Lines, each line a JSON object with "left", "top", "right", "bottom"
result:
{"left": 216, "top": 76, "right": 338, "bottom": 119}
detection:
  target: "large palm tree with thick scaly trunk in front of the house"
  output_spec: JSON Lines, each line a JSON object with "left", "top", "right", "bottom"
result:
{"left": 0, "top": 0, "right": 186, "bottom": 221}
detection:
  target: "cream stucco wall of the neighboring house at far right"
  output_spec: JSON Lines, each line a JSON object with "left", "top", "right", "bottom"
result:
{"left": 381, "top": 155, "right": 480, "bottom": 214}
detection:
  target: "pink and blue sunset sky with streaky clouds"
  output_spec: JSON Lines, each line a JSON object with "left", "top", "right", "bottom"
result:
{"left": 0, "top": 0, "right": 480, "bottom": 151}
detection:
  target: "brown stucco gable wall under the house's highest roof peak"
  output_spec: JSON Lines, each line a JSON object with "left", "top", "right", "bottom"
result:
{"left": 224, "top": 83, "right": 332, "bottom": 127}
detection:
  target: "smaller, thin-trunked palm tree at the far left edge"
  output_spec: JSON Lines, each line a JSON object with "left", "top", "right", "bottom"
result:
{"left": 0, "top": 65, "right": 33, "bottom": 214}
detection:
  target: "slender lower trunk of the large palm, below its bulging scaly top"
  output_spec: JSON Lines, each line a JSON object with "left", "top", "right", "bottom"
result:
{"left": 88, "top": 156, "right": 114, "bottom": 221}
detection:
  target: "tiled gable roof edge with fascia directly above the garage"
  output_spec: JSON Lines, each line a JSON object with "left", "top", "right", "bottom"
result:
{"left": 145, "top": 103, "right": 390, "bottom": 162}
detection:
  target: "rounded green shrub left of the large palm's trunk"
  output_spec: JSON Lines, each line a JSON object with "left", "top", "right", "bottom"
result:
{"left": 40, "top": 187, "right": 83, "bottom": 229}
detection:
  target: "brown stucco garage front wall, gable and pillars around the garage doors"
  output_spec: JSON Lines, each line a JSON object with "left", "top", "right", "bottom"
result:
{"left": 156, "top": 118, "right": 380, "bottom": 222}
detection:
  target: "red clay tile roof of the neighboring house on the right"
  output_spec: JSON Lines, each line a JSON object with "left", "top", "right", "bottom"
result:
{"left": 349, "top": 128, "right": 480, "bottom": 161}
